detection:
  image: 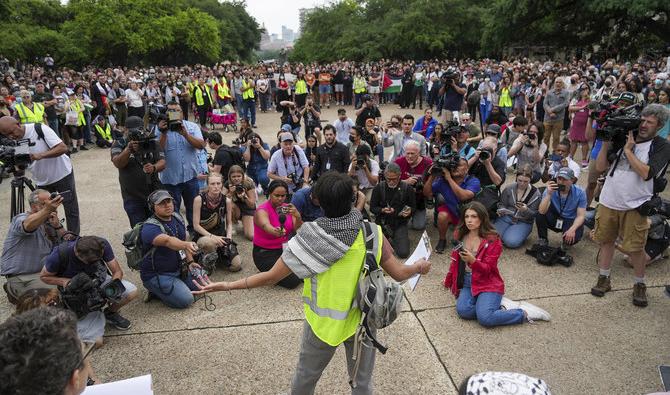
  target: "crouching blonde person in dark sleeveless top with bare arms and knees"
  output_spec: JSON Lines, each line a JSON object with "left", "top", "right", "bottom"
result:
{"left": 193, "top": 173, "right": 242, "bottom": 272}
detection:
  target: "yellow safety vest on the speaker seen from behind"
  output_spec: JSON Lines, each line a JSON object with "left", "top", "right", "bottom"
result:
{"left": 302, "top": 226, "right": 383, "bottom": 347}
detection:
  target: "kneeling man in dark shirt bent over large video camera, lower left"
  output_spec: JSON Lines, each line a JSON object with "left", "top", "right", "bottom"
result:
{"left": 40, "top": 236, "right": 137, "bottom": 341}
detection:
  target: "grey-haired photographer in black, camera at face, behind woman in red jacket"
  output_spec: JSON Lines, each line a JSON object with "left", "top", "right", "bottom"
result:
{"left": 468, "top": 137, "right": 506, "bottom": 218}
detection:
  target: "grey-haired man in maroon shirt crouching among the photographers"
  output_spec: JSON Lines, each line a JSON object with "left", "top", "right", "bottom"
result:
{"left": 395, "top": 140, "right": 433, "bottom": 230}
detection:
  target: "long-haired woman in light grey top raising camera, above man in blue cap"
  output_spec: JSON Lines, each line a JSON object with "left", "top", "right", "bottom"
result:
{"left": 507, "top": 121, "right": 547, "bottom": 184}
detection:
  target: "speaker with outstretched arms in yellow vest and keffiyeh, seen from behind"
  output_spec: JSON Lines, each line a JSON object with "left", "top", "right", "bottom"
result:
{"left": 193, "top": 171, "right": 431, "bottom": 394}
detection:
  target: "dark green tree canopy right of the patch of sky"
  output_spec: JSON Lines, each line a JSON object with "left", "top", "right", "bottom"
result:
{"left": 292, "top": 0, "right": 670, "bottom": 61}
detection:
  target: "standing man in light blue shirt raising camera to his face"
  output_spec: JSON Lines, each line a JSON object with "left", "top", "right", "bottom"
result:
{"left": 157, "top": 102, "right": 205, "bottom": 231}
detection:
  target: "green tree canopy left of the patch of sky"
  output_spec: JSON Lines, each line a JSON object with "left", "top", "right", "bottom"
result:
{"left": 0, "top": 0, "right": 261, "bottom": 65}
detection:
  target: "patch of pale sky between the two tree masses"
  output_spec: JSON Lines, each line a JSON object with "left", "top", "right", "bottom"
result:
{"left": 245, "top": 0, "right": 330, "bottom": 38}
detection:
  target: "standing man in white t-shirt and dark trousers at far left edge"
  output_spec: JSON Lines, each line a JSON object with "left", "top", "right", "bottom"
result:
{"left": 0, "top": 116, "right": 79, "bottom": 234}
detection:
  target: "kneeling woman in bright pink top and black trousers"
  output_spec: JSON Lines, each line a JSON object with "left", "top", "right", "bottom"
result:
{"left": 253, "top": 180, "right": 302, "bottom": 289}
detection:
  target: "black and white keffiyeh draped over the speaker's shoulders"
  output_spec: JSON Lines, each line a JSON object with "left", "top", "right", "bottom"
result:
{"left": 282, "top": 209, "right": 363, "bottom": 278}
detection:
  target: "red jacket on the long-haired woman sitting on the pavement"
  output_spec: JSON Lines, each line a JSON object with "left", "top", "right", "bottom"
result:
{"left": 443, "top": 235, "right": 505, "bottom": 297}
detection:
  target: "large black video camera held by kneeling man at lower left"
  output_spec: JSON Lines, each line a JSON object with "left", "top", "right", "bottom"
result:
{"left": 58, "top": 262, "right": 126, "bottom": 318}
